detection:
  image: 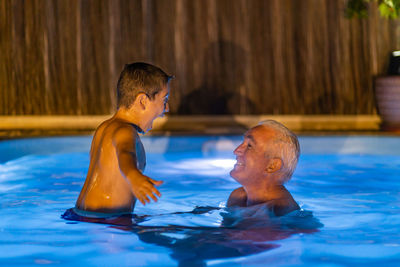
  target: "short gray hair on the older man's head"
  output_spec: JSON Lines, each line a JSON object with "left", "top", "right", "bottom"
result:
{"left": 258, "top": 120, "right": 300, "bottom": 182}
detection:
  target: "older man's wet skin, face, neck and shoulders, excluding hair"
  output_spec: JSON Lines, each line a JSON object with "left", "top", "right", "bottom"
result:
{"left": 227, "top": 126, "right": 300, "bottom": 216}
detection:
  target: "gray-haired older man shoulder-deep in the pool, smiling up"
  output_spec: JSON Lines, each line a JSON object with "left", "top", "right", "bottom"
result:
{"left": 227, "top": 120, "right": 300, "bottom": 216}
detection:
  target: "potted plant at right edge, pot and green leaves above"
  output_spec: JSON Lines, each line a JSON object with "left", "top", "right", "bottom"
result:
{"left": 346, "top": 0, "right": 400, "bottom": 132}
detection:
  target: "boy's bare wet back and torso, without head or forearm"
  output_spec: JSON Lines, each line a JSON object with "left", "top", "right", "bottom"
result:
{"left": 76, "top": 117, "right": 146, "bottom": 215}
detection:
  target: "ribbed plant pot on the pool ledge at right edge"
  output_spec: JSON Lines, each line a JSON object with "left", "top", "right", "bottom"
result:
{"left": 375, "top": 75, "right": 400, "bottom": 132}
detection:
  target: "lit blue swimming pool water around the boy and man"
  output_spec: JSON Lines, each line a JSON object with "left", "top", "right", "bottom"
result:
{"left": 0, "top": 136, "right": 400, "bottom": 266}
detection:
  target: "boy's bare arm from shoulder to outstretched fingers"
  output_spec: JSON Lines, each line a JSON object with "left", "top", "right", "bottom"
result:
{"left": 113, "top": 126, "right": 163, "bottom": 205}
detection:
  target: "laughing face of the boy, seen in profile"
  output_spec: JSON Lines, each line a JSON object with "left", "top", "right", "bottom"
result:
{"left": 143, "top": 85, "right": 169, "bottom": 132}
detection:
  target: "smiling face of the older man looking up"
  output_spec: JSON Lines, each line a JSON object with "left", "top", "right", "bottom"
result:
{"left": 230, "top": 126, "right": 275, "bottom": 185}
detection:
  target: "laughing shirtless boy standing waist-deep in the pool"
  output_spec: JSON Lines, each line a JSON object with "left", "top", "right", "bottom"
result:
{"left": 75, "top": 62, "right": 172, "bottom": 215}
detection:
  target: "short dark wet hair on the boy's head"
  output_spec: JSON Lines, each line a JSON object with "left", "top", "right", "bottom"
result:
{"left": 117, "top": 62, "right": 173, "bottom": 108}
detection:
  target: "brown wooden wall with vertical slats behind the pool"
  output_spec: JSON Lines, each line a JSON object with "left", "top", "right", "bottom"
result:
{"left": 0, "top": 0, "right": 400, "bottom": 115}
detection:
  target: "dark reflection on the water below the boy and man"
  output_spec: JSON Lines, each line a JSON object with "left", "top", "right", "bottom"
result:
{"left": 62, "top": 205, "right": 322, "bottom": 266}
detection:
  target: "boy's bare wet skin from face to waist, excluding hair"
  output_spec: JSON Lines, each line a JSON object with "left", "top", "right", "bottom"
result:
{"left": 76, "top": 87, "right": 169, "bottom": 213}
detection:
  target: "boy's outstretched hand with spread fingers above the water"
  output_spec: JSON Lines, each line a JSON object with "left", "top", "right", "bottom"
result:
{"left": 130, "top": 175, "right": 163, "bottom": 205}
